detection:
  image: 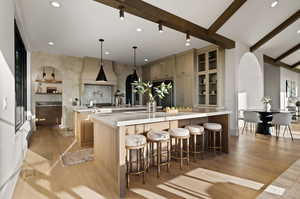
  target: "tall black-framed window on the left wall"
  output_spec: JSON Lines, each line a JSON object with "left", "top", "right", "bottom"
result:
{"left": 15, "top": 22, "right": 27, "bottom": 130}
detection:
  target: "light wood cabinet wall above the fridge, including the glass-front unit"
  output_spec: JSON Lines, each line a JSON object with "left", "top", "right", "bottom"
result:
{"left": 143, "top": 46, "right": 224, "bottom": 107}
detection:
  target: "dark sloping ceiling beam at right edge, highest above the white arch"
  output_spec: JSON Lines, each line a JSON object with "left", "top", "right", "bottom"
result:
{"left": 250, "top": 10, "right": 300, "bottom": 52}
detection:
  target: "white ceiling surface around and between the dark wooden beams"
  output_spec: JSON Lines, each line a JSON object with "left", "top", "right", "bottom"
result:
{"left": 17, "top": 0, "right": 300, "bottom": 67}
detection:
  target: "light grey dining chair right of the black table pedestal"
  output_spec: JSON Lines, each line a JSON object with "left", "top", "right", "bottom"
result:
{"left": 272, "top": 113, "right": 294, "bottom": 140}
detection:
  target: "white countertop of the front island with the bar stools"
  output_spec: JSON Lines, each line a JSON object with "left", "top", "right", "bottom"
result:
{"left": 91, "top": 110, "right": 231, "bottom": 127}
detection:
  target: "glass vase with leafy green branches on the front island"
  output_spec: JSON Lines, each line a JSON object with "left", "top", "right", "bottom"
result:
{"left": 132, "top": 79, "right": 172, "bottom": 112}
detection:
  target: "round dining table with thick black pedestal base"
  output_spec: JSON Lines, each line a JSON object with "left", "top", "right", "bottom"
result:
{"left": 247, "top": 109, "right": 290, "bottom": 135}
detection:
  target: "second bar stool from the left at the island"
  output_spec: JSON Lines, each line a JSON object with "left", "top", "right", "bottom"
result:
{"left": 147, "top": 131, "right": 171, "bottom": 178}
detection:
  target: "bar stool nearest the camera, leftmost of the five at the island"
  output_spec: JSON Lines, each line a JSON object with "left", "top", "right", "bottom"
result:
{"left": 125, "top": 135, "right": 147, "bottom": 188}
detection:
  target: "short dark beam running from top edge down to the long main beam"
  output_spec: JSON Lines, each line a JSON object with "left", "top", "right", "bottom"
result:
{"left": 208, "top": 0, "right": 247, "bottom": 33}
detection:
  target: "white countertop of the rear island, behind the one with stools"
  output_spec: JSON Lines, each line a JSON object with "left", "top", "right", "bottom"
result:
{"left": 73, "top": 105, "right": 157, "bottom": 113}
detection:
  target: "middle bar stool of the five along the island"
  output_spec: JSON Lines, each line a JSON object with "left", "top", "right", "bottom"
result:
{"left": 170, "top": 128, "right": 190, "bottom": 169}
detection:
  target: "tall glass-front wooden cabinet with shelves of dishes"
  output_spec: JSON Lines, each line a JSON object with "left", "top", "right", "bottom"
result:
{"left": 196, "top": 47, "right": 224, "bottom": 106}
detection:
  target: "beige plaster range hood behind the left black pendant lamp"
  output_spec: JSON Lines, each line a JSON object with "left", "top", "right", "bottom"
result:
{"left": 80, "top": 57, "right": 117, "bottom": 85}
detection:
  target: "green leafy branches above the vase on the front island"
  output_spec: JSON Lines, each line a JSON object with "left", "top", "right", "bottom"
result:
{"left": 132, "top": 79, "right": 172, "bottom": 102}
